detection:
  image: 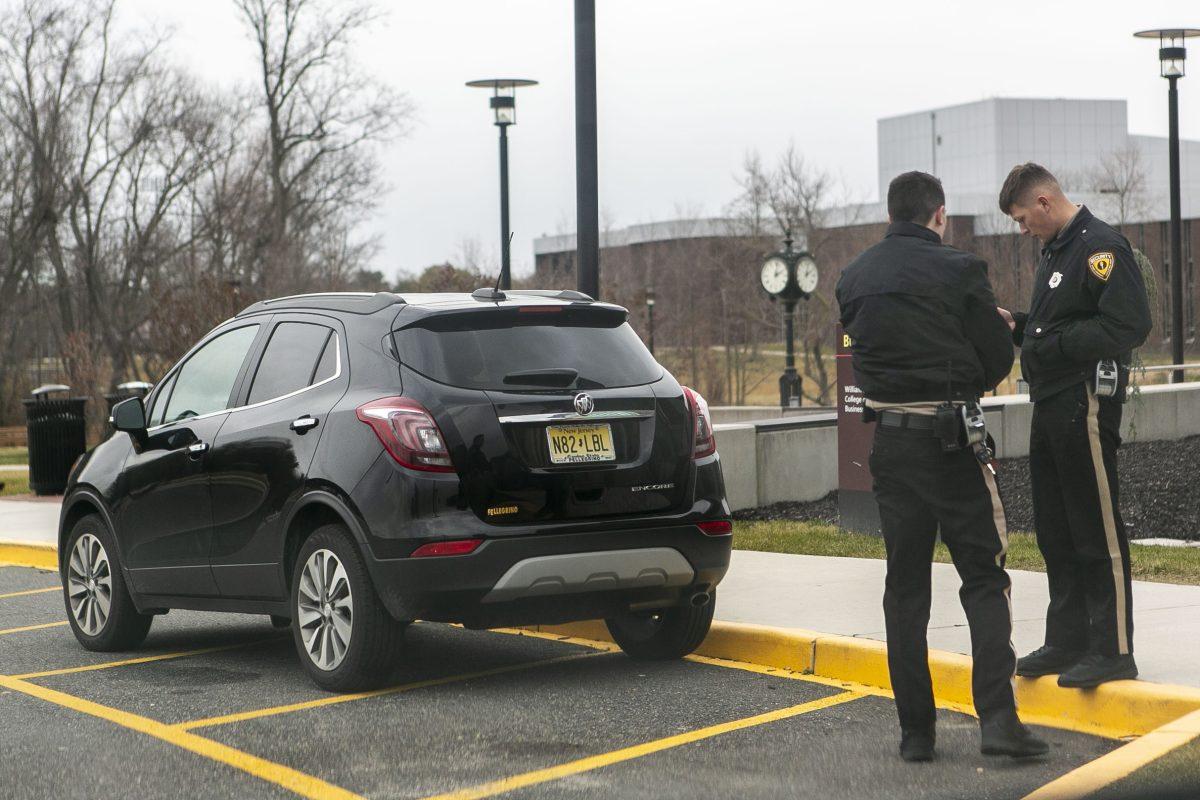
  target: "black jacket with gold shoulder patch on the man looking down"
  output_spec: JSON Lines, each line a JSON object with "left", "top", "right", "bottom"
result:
{"left": 1013, "top": 206, "right": 1151, "bottom": 402}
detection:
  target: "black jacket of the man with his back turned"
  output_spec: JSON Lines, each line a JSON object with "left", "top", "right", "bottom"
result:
{"left": 838, "top": 222, "right": 1013, "bottom": 403}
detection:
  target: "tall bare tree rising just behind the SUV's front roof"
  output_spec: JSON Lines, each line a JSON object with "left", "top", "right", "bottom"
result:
{"left": 235, "top": 0, "right": 412, "bottom": 293}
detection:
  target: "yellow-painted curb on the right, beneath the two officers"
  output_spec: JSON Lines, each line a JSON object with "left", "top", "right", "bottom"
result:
{"left": 533, "top": 620, "right": 1200, "bottom": 739}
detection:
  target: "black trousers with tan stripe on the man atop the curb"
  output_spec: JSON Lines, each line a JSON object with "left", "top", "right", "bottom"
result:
{"left": 1030, "top": 383, "right": 1133, "bottom": 655}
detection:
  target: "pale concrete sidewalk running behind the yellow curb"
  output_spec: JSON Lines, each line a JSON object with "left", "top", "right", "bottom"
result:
{"left": 0, "top": 500, "right": 1200, "bottom": 687}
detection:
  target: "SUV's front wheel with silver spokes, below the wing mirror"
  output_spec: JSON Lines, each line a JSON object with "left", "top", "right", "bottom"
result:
{"left": 59, "top": 513, "right": 154, "bottom": 652}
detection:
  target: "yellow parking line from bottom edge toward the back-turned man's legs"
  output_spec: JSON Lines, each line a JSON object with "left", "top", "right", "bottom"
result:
{"left": 412, "top": 692, "right": 864, "bottom": 800}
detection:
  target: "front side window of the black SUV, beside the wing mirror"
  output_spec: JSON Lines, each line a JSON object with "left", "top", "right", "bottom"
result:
{"left": 162, "top": 325, "right": 258, "bottom": 422}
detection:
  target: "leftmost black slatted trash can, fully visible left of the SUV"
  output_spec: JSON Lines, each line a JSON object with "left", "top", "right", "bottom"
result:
{"left": 22, "top": 384, "right": 88, "bottom": 494}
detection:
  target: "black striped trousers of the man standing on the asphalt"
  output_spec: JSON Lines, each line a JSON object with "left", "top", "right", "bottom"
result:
{"left": 871, "top": 426, "right": 1016, "bottom": 730}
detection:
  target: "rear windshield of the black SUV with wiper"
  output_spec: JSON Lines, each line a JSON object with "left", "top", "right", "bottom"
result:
{"left": 395, "top": 312, "right": 662, "bottom": 390}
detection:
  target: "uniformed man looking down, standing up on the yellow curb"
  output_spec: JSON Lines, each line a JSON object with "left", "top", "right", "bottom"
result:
{"left": 1000, "top": 163, "right": 1151, "bottom": 687}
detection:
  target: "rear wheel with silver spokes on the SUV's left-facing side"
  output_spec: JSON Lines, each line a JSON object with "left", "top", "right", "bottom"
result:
{"left": 292, "top": 524, "right": 407, "bottom": 692}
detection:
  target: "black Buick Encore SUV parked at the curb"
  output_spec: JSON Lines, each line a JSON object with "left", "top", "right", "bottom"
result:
{"left": 59, "top": 289, "right": 732, "bottom": 691}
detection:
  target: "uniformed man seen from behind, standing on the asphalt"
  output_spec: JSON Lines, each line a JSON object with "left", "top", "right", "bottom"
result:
{"left": 838, "top": 172, "right": 1046, "bottom": 760}
